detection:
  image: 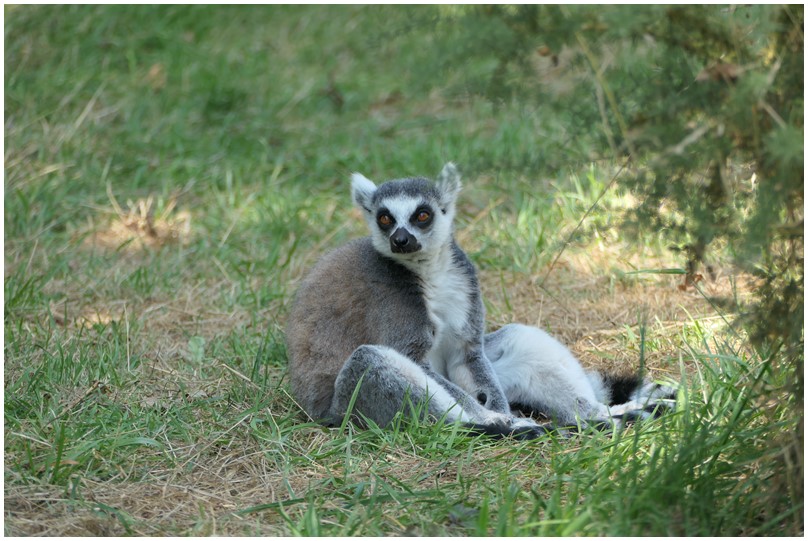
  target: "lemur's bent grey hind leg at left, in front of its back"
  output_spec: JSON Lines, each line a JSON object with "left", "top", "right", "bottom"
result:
{"left": 330, "top": 345, "right": 544, "bottom": 439}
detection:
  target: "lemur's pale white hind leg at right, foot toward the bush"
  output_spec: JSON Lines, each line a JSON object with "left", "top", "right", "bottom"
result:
{"left": 484, "top": 324, "right": 671, "bottom": 426}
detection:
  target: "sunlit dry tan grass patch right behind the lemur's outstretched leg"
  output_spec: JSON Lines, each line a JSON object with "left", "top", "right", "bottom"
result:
{"left": 481, "top": 239, "right": 753, "bottom": 377}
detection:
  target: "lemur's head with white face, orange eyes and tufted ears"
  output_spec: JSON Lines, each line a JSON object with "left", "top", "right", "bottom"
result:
{"left": 351, "top": 163, "right": 460, "bottom": 261}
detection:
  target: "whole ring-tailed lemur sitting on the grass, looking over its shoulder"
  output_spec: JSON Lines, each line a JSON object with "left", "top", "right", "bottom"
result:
{"left": 286, "top": 163, "right": 672, "bottom": 438}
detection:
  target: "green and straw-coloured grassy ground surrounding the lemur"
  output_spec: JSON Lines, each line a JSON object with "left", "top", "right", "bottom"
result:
{"left": 4, "top": 6, "right": 802, "bottom": 536}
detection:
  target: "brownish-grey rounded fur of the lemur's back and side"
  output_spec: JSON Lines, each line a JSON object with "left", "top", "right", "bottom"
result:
{"left": 286, "top": 238, "right": 431, "bottom": 420}
